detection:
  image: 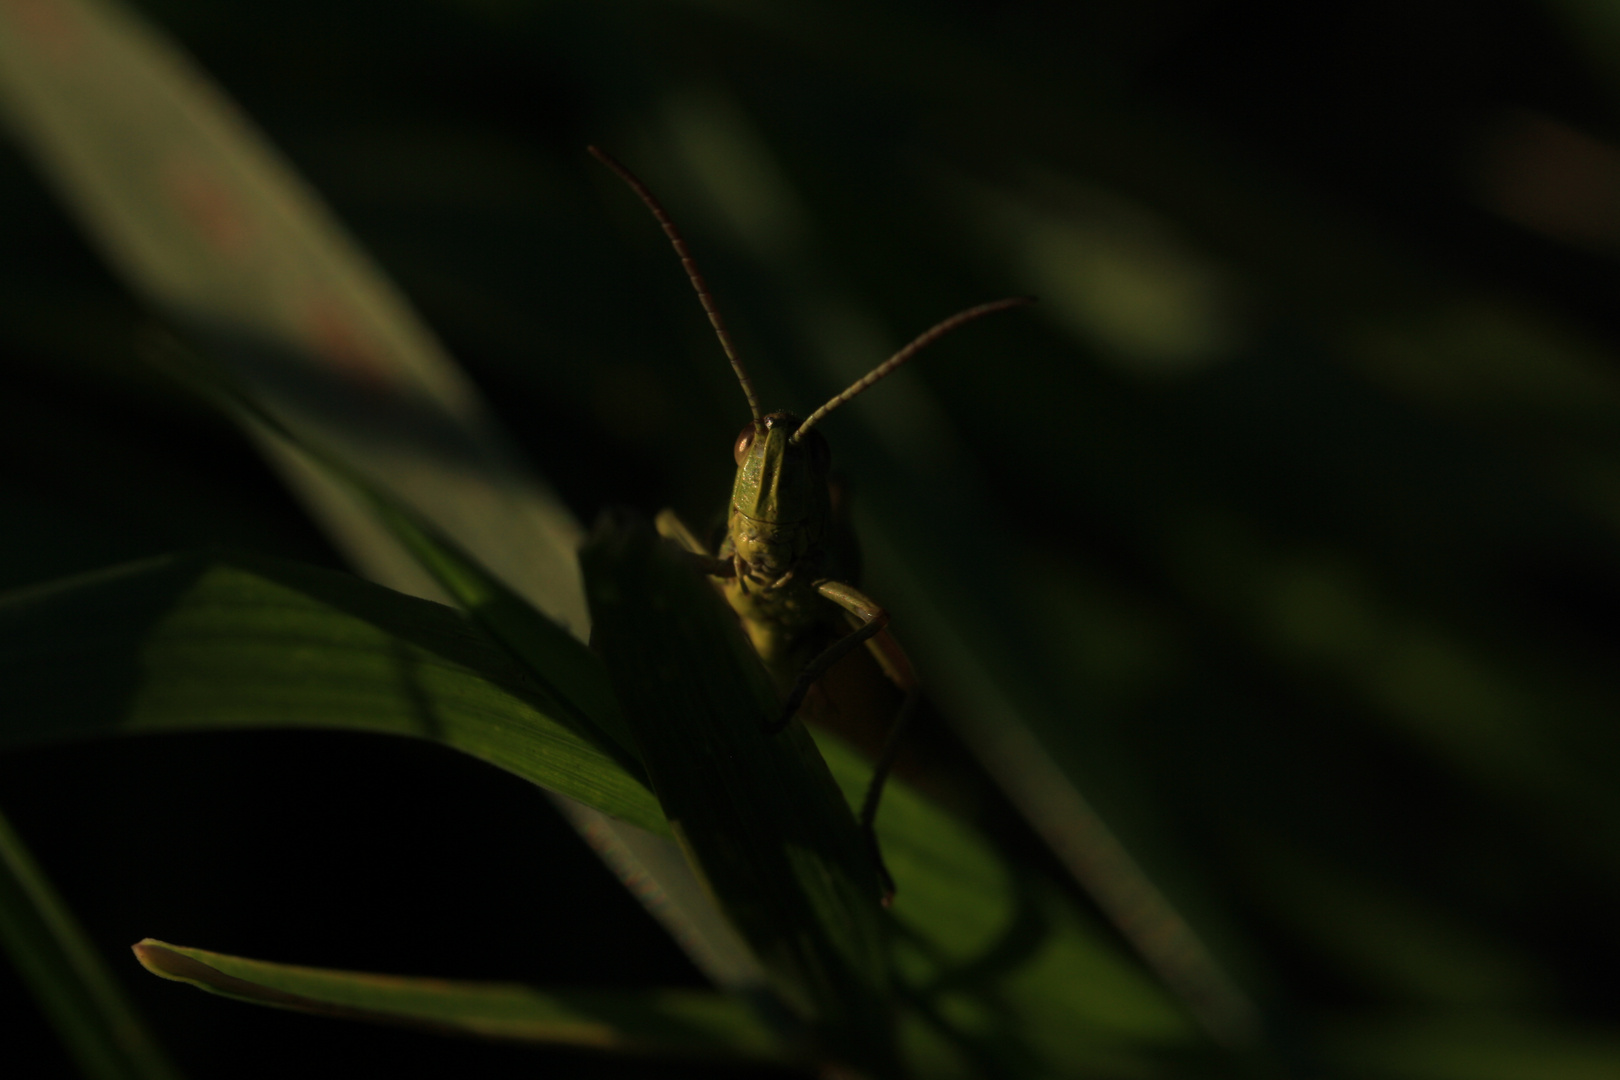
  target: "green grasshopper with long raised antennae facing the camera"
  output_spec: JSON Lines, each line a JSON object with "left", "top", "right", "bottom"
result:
{"left": 586, "top": 146, "right": 1032, "bottom": 905}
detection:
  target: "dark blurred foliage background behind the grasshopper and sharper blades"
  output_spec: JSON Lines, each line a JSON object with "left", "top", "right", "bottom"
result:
{"left": 0, "top": 0, "right": 1620, "bottom": 1080}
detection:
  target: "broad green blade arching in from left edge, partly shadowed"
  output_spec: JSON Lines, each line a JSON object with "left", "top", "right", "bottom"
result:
{"left": 0, "top": 554, "right": 667, "bottom": 831}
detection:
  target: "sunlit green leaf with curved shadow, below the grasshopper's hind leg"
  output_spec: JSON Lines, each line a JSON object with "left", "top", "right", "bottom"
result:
{"left": 816, "top": 733, "right": 1218, "bottom": 1077}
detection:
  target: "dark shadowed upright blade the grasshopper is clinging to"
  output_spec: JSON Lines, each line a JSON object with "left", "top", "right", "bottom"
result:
{"left": 582, "top": 523, "right": 894, "bottom": 1072}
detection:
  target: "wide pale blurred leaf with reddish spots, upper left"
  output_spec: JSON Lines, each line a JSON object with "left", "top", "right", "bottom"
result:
{"left": 0, "top": 0, "right": 585, "bottom": 635}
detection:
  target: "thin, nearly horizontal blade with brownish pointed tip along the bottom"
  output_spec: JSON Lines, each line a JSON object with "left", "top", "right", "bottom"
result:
{"left": 134, "top": 938, "right": 795, "bottom": 1065}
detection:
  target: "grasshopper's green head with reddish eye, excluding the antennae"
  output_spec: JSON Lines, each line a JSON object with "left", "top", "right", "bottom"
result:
{"left": 726, "top": 413, "right": 833, "bottom": 581}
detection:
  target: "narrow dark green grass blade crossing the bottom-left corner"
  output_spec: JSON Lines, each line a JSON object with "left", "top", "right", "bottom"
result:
{"left": 0, "top": 814, "right": 180, "bottom": 1080}
